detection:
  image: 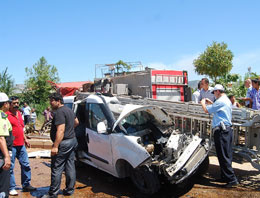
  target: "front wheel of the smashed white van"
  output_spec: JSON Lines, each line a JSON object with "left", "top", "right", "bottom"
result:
{"left": 130, "top": 166, "right": 160, "bottom": 195}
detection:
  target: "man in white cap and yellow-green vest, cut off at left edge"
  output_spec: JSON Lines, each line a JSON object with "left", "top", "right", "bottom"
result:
{"left": 0, "top": 92, "right": 13, "bottom": 197}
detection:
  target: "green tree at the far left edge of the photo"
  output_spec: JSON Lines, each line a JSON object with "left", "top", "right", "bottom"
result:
{"left": 0, "top": 67, "right": 14, "bottom": 95}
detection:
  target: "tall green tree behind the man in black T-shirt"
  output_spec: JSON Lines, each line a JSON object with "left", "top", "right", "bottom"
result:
{"left": 23, "top": 57, "right": 59, "bottom": 111}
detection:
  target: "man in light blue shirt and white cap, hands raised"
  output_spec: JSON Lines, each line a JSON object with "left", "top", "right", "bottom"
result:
{"left": 201, "top": 84, "right": 239, "bottom": 188}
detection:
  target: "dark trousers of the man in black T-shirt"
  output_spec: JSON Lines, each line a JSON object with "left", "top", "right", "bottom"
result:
{"left": 49, "top": 138, "right": 77, "bottom": 196}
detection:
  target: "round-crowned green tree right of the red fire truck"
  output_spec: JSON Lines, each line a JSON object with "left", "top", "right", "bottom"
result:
{"left": 193, "top": 42, "right": 233, "bottom": 83}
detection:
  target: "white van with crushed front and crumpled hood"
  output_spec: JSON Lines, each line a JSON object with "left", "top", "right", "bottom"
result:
{"left": 74, "top": 94, "right": 209, "bottom": 194}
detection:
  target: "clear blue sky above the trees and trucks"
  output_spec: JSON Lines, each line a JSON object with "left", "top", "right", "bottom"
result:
{"left": 0, "top": 0, "right": 260, "bottom": 84}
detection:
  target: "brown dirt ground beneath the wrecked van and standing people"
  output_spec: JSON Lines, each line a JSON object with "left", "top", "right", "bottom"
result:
{"left": 11, "top": 149, "right": 260, "bottom": 198}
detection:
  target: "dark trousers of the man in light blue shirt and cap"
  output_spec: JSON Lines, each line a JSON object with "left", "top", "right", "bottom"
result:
{"left": 214, "top": 126, "right": 237, "bottom": 182}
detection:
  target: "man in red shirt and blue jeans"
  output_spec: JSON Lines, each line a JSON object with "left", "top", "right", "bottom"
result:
{"left": 7, "top": 96, "right": 36, "bottom": 195}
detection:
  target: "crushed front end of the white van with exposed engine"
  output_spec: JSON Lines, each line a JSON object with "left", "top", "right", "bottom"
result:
{"left": 139, "top": 130, "right": 210, "bottom": 184}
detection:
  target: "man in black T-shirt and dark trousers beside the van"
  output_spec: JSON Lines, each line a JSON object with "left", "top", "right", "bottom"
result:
{"left": 43, "top": 93, "right": 79, "bottom": 198}
